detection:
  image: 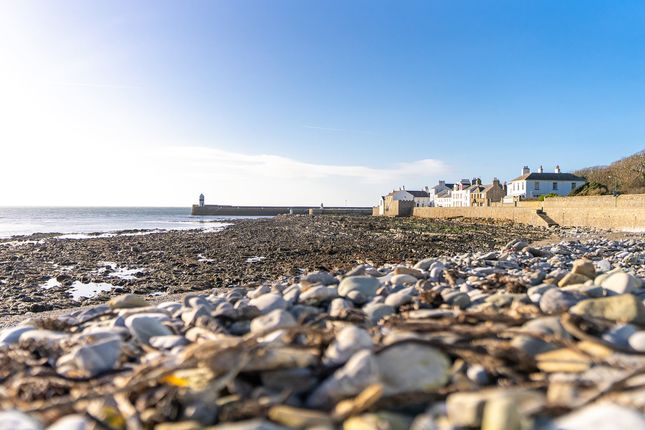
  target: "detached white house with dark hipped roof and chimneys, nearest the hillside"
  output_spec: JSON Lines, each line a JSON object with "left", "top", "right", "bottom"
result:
{"left": 505, "top": 166, "right": 586, "bottom": 200}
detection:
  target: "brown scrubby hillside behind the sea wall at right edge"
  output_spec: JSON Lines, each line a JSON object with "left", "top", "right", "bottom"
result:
{"left": 575, "top": 150, "right": 645, "bottom": 195}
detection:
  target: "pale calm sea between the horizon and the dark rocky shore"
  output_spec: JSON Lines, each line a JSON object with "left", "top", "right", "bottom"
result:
{"left": 0, "top": 207, "right": 247, "bottom": 238}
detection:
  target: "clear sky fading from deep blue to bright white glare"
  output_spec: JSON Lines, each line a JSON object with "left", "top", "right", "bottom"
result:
{"left": 0, "top": 0, "right": 645, "bottom": 205}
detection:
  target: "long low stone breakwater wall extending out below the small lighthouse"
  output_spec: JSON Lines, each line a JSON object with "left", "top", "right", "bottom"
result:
{"left": 191, "top": 205, "right": 372, "bottom": 216}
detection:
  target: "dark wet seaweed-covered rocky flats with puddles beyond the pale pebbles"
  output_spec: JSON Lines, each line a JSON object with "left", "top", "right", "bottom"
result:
{"left": 0, "top": 216, "right": 555, "bottom": 316}
